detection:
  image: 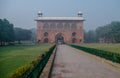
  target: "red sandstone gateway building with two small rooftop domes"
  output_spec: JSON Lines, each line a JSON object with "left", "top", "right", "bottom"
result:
{"left": 35, "top": 12, "right": 84, "bottom": 43}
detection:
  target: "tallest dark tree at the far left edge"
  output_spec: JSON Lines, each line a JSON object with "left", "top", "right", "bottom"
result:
{"left": 0, "top": 19, "right": 15, "bottom": 45}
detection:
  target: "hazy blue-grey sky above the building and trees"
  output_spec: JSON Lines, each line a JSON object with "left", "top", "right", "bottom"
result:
{"left": 0, "top": 0, "right": 120, "bottom": 30}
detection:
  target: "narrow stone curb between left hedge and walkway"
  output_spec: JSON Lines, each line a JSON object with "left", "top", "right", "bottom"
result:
{"left": 39, "top": 46, "right": 57, "bottom": 78}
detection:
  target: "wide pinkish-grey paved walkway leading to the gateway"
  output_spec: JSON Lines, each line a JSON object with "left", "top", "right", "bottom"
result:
{"left": 51, "top": 45, "right": 120, "bottom": 78}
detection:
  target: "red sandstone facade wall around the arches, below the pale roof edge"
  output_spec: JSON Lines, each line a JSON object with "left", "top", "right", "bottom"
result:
{"left": 37, "top": 21, "right": 84, "bottom": 43}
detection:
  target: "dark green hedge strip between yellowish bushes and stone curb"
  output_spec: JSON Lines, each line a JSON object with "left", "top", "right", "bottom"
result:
{"left": 24, "top": 45, "right": 56, "bottom": 78}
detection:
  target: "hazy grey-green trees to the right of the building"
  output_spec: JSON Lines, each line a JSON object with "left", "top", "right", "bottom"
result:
{"left": 84, "top": 21, "right": 120, "bottom": 43}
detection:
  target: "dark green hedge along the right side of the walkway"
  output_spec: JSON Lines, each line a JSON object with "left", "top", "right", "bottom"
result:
{"left": 70, "top": 44, "right": 120, "bottom": 63}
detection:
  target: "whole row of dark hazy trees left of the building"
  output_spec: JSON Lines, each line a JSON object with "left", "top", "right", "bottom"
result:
{"left": 0, "top": 19, "right": 32, "bottom": 45}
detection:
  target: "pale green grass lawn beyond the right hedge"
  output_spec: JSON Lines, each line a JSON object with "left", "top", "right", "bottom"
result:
{"left": 81, "top": 44, "right": 120, "bottom": 53}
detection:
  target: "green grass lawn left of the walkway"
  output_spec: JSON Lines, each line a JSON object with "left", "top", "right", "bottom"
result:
{"left": 0, "top": 44, "right": 52, "bottom": 78}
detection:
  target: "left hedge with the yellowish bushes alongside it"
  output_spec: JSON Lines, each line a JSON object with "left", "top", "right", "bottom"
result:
{"left": 10, "top": 45, "right": 55, "bottom": 78}
